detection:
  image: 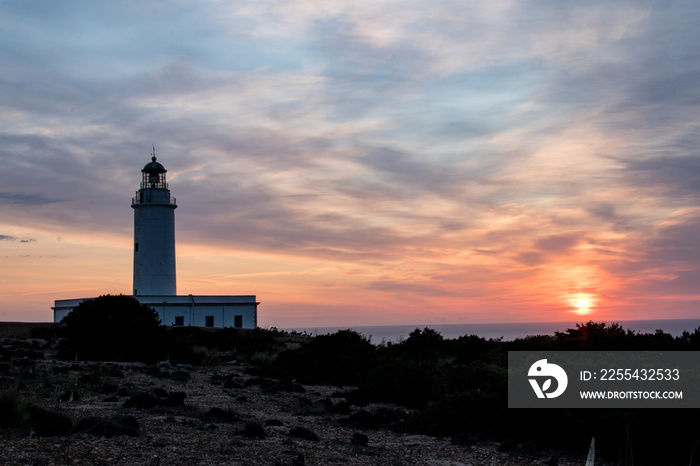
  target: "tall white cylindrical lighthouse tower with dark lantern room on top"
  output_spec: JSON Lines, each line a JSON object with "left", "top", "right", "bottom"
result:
{"left": 131, "top": 148, "right": 177, "bottom": 296}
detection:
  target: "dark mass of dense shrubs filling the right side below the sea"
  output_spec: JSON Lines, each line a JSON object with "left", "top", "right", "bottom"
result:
{"left": 259, "top": 322, "right": 700, "bottom": 464}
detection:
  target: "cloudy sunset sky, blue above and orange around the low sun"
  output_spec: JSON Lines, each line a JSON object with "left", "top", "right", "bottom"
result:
{"left": 0, "top": 0, "right": 700, "bottom": 327}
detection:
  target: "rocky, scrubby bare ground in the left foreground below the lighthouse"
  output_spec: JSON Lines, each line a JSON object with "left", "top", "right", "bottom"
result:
{"left": 0, "top": 340, "right": 585, "bottom": 465}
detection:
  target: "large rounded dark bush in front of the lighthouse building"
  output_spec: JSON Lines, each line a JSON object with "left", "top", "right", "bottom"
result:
{"left": 58, "top": 295, "right": 162, "bottom": 362}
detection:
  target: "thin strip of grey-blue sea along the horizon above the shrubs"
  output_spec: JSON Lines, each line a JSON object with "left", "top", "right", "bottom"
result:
{"left": 283, "top": 319, "right": 700, "bottom": 345}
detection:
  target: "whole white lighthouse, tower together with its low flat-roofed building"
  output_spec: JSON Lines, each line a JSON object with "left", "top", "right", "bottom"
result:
{"left": 53, "top": 150, "right": 260, "bottom": 328}
